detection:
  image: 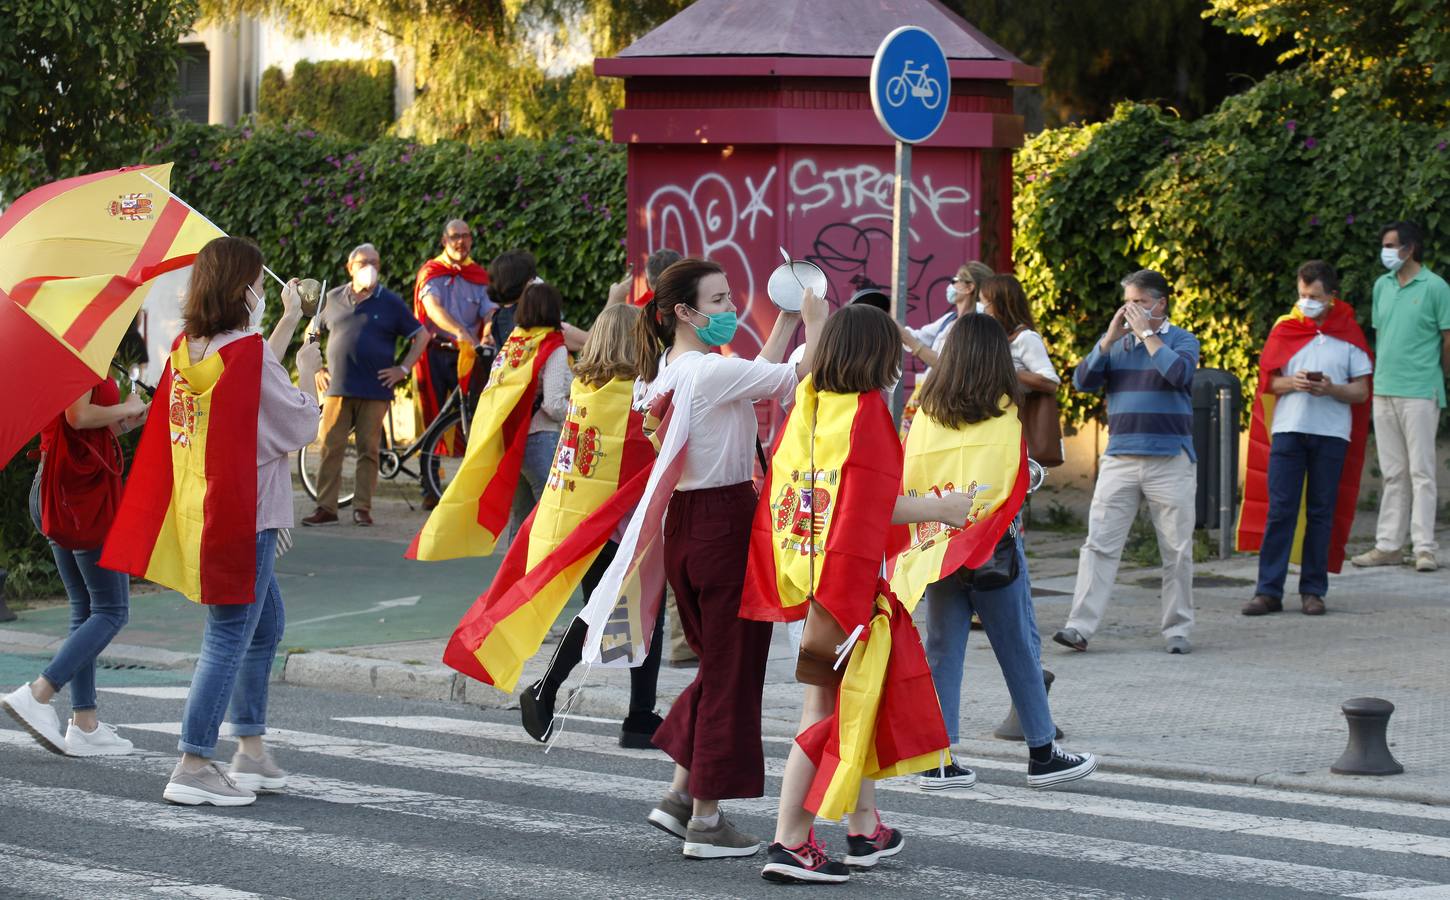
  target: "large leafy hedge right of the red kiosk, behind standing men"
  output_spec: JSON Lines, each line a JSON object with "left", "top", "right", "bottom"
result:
{"left": 1014, "top": 74, "right": 1450, "bottom": 423}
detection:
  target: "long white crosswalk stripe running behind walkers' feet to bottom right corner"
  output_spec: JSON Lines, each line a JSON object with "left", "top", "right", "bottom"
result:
{"left": 113, "top": 722, "right": 1450, "bottom": 896}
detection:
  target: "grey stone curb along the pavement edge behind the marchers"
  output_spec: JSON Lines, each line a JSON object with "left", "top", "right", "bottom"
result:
{"left": 278, "top": 651, "right": 1450, "bottom": 806}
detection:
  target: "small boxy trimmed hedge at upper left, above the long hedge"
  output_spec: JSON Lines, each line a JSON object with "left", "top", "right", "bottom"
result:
{"left": 257, "top": 59, "right": 396, "bottom": 141}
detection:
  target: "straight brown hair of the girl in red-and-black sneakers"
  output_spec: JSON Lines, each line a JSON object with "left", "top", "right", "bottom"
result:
{"left": 811, "top": 303, "right": 902, "bottom": 394}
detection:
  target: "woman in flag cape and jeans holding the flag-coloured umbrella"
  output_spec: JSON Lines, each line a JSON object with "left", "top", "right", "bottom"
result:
{"left": 102, "top": 238, "right": 322, "bottom": 806}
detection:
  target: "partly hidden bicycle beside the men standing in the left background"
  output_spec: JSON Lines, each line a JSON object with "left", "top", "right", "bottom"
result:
{"left": 297, "top": 376, "right": 470, "bottom": 509}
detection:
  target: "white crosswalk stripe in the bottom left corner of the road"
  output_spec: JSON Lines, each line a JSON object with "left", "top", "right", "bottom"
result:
{"left": 0, "top": 843, "right": 280, "bottom": 900}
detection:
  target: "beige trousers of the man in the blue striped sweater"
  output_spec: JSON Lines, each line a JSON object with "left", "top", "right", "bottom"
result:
{"left": 1067, "top": 454, "right": 1198, "bottom": 638}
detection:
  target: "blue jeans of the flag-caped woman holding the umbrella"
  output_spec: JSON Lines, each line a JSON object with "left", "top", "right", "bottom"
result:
{"left": 177, "top": 529, "right": 287, "bottom": 757}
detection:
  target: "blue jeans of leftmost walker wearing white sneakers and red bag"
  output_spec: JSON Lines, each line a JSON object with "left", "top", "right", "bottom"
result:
{"left": 41, "top": 541, "right": 131, "bottom": 710}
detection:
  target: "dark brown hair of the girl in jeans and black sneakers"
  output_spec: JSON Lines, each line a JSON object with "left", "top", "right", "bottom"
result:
{"left": 921, "top": 313, "right": 1022, "bottom": 428}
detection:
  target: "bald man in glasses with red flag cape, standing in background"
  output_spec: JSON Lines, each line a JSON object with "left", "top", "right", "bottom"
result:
{"left": 413, "top": 219, "right": 496, "bottom": 478}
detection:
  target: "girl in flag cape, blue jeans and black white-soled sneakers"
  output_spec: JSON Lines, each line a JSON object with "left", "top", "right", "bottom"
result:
{"left": 892, "top": 313, "right": 1098, "bottom": 790}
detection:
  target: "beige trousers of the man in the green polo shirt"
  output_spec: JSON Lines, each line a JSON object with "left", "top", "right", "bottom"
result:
{"left": 1375, "top": 396, "right": 1440, "bottom": 554}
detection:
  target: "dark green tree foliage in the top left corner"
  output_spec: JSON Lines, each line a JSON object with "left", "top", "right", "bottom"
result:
{"left": 0, "top": 0, "right": 197, "bottom": 181}
